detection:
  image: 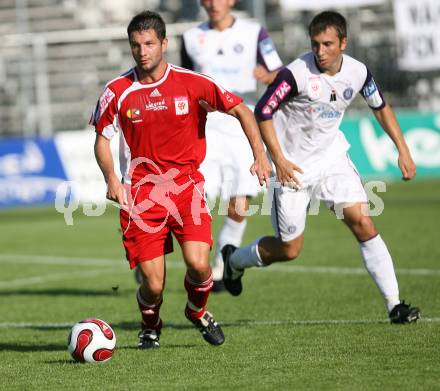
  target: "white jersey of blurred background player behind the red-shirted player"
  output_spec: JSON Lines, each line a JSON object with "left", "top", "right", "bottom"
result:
{"left": 182, "top": 19, "right": 282, "bottom": 98}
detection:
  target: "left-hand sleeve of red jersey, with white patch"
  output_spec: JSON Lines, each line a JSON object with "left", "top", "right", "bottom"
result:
{"left": 89, "top": 87, "right": 119, "bottom": 140}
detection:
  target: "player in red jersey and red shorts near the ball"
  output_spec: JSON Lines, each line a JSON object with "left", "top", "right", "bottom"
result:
{"left": 91, "top": 11, "right": 271, "bottom": 348}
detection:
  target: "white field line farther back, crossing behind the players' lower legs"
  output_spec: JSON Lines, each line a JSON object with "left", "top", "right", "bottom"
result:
{"left": 0, "top": 254, "right": 440, "bottom": 276}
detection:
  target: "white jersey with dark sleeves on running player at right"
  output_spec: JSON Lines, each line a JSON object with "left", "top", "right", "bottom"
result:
{"left": 255, "top": 53, "right": 385, "bottom": 184}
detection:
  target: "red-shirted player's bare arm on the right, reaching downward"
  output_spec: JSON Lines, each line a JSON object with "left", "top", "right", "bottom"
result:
{"left": 228, "top": 103, "right": 272, "bottom": 186}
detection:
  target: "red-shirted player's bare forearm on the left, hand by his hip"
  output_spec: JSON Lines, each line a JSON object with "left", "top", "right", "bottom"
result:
{"left": 95, "top": 133, "right": 128, "bottom": 206}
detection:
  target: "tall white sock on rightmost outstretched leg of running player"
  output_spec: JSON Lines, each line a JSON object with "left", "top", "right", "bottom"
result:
{"left": 360, "top": 235, "right": 400, "bottom": 312}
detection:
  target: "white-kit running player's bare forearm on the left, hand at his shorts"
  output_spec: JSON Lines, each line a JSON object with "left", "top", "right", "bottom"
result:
{"left": 258, "top": 119, "right": 303, "bottom": 189}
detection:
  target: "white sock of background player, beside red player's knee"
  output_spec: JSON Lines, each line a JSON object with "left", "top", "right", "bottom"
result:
{"left": 212, "top": 216, "right": 247, "bottom": 281}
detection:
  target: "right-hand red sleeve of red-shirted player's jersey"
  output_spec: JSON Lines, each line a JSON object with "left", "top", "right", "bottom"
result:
{"left": 197, "top": 75, "right": 243, "bottom": 112}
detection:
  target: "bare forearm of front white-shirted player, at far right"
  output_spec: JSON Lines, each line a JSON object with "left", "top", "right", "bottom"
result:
{"left": 374, "top": 104, "right": 416, "bottom": 181}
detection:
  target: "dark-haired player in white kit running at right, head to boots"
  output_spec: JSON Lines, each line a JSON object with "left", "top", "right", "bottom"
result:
{"left": 222, "top": 11, "right": 420, "bottom": 323}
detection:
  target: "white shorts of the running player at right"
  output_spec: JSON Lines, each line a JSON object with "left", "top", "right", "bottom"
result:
{"left": 271, "top": 155, "right": 368, "bottom": 242}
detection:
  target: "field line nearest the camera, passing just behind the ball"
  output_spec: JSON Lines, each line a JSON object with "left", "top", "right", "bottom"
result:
{"left": 0, "top": 318, "right": 440, "bottom": 329}
